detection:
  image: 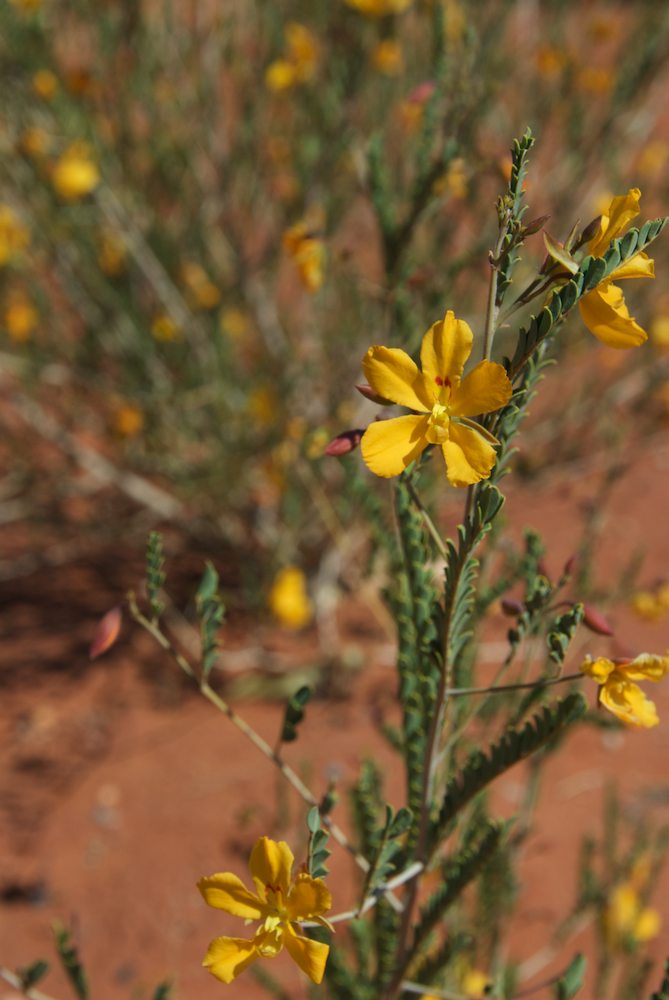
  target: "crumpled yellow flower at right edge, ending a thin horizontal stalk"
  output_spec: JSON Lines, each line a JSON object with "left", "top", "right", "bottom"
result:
{"left": 581, "top": 653, "right": 669, "bottom": 729}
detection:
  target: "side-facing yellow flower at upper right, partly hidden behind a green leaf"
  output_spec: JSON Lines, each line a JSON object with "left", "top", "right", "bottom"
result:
{"left": 579, "top": 188, "right": 655, "bottom": 348}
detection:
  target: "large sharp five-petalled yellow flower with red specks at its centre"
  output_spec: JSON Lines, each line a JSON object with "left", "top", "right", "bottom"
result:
{"left": 361, "top": 310, "right": 511, "bottom": 486}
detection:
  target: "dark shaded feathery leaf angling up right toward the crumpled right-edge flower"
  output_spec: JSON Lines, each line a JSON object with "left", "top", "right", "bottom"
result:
{"left": 430, "top": 694, "right": 587, "bottom": 848}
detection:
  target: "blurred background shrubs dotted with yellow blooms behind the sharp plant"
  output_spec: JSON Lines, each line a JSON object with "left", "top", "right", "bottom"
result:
{"left": 0, "top": 0, "right": 669, "bottom": 618}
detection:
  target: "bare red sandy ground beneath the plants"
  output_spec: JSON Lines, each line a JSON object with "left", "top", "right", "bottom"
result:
{"left": 0, "top": 432, "right": 669, "bottom": 1000}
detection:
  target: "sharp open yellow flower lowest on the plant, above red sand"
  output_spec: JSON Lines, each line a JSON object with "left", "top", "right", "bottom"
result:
{"left": 198, "top": 837, "right": 332, "bottom": 983}
